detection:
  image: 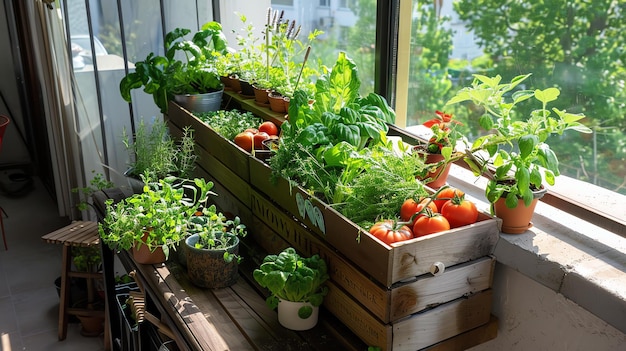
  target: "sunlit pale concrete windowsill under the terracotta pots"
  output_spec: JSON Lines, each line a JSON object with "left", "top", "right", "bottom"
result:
{"left": 448, "top": 165, "right": 626, "bottom": 333}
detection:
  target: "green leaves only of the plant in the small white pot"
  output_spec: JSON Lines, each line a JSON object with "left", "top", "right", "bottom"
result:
{"left": 253, "top": 247, "right": 329, "bottom": 309}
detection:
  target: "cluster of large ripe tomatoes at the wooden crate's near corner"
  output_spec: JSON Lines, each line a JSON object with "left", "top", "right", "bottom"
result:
{"left": 369, "top": 187, "right": 478, "bottom": 245}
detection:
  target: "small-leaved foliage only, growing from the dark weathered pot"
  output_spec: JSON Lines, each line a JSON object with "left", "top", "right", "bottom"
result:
{"left": 187, "top": 205, "right": 247, "bottom": 262}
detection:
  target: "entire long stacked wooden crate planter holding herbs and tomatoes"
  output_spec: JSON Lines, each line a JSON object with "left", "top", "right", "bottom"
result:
{"left": 169, "top": 99, "right": 499, "bottom": 350}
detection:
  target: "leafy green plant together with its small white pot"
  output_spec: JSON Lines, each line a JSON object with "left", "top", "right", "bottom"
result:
{"left": 253, "top": 247, "right": 329, "bottom": 330}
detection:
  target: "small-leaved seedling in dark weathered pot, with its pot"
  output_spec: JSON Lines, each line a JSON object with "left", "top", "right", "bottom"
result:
{"left": 184, "top": 205, "right": 246, "bottom": 288}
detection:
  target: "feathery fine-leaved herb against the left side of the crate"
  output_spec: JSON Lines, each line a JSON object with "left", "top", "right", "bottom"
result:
{"left": 122, "top": 119, "right": 197, "bottom": 179}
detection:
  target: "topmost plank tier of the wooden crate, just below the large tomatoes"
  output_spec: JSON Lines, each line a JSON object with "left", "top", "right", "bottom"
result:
{"left": 250, "top": 159, "right": 500, "bottom": 287}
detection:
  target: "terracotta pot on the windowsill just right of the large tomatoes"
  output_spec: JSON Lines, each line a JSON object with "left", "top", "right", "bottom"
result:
{"left": 493, "top": 189, "right": 546, "bottom": 234}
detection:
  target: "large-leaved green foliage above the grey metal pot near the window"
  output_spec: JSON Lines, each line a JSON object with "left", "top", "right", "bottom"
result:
{"left": 120, "top": 22, "right": 228, "bottom": 113}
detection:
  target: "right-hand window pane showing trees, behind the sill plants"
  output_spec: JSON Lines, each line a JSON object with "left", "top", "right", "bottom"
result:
{"left": 398, "top": 0, "right": 626, "bottom": 194}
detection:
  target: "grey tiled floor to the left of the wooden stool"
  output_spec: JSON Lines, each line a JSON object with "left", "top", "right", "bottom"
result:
{"left": 0, "top": 171, "right": 104, "bottom": 351}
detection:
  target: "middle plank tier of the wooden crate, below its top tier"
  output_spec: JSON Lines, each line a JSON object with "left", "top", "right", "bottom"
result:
{"left": 251, "top": 190, "right": 495, "bottom": 324}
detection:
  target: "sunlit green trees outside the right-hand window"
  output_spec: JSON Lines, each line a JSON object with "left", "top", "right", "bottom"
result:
{"left": 454, "top": 0, "right": 626, "bottom": 194}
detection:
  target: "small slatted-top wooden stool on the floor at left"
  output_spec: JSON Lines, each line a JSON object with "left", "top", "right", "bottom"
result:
{"left": 41, "top": 221, "right": 106, "bottom": 340}
